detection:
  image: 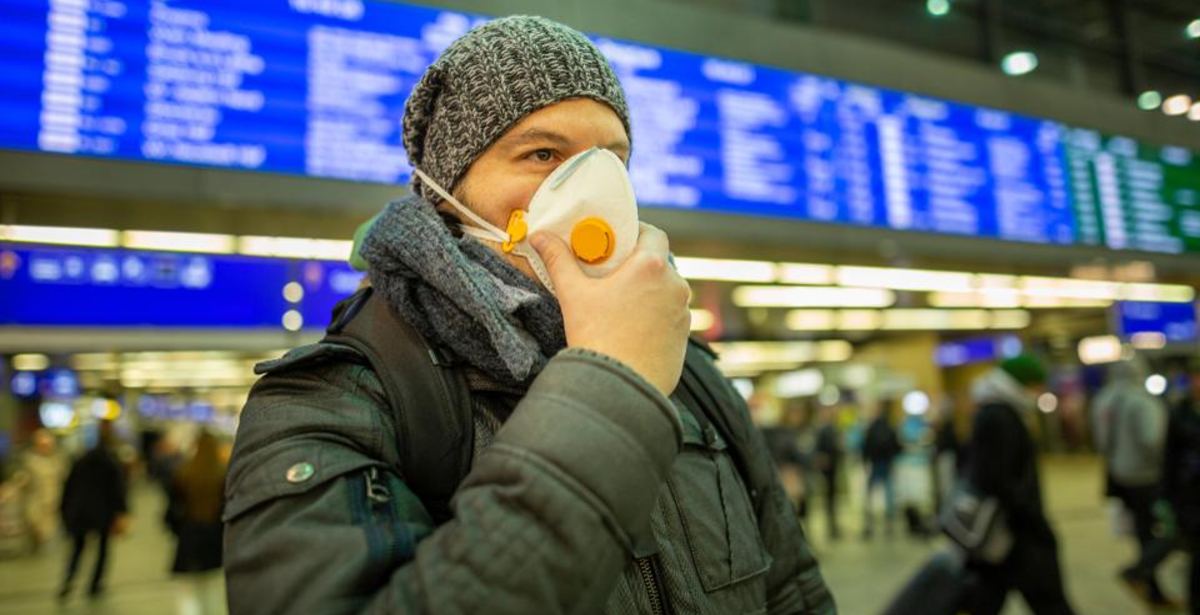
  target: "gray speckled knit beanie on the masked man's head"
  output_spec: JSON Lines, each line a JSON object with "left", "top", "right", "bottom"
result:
{"left": 403, "top": 16, "right": 630, "bottom": 204}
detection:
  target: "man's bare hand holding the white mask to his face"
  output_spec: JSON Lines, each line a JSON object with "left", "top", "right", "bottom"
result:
{"left": 530, "top": 223, "right": 691, "bottom": 395}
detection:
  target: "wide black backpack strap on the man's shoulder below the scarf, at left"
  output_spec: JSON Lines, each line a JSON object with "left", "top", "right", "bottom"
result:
{"left": 323, "top": 287, "right": 474, "bottom": 524}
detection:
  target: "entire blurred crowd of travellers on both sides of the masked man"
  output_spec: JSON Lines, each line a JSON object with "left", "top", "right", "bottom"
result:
{"left": 0, "top": 356, "right": 1200, "bottom": 615}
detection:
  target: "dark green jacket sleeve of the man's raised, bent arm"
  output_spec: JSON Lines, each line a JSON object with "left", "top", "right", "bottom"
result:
{"left": 226, "top": 350, "right": 682, "bottom": 615}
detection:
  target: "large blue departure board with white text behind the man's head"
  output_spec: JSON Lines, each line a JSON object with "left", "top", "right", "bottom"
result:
{"left": 0, "top": 0, "right": 1200, "bottom": 252}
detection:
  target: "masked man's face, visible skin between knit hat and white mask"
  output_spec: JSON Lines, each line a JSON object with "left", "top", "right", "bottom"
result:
{"left": 442, "top": 98, "right": 629, "bottom": 280}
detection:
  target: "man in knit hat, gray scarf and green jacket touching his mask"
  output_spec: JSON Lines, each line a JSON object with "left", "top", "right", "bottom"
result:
{"left": 224, "top": 17, "right": 835, "bottom": 615}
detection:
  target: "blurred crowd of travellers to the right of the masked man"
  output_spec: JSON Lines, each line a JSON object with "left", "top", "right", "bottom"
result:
{"left": 750, "top": 356, "right": 1200, "bottom": 615}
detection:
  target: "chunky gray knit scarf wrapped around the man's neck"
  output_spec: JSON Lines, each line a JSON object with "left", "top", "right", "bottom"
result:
{"left": 360, "top": 196, "right": 566, "bottom": 386}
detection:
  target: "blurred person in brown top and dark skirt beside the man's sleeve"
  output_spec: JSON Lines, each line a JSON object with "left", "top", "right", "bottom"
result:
{"left": 169, "top": 431, "right": 226, "bottom": 614}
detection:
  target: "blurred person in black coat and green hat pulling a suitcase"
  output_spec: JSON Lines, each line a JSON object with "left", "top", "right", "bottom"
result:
{"left": 966, "top": 354, "right": 1074, "bottom": 615}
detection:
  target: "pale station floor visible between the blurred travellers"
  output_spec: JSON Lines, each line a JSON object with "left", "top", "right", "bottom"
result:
{"left": 0, "top": 458, "right": 1184, "bottom": 615}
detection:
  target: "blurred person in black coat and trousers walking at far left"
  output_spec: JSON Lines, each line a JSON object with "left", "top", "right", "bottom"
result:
{"left": 59, "top": 420, "right": 128, "bottom": 598}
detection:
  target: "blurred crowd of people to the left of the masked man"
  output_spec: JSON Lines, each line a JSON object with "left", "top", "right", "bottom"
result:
{"left": 0, "top": 420, "right": 229, "bottom": 615}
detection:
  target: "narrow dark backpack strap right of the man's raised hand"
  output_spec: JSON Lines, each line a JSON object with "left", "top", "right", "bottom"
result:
{"left": 679, "top": 339, "right": 774, "bottom": 515}
